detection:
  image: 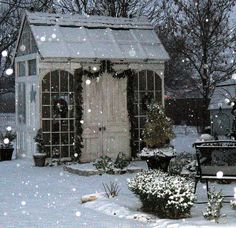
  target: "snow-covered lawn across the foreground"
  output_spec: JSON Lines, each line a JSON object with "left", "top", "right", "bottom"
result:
{"left": 0, "top": 159, "right": 236, "bottom": 228}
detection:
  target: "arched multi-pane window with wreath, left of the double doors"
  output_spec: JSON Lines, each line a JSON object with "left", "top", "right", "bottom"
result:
{"left": 42, "top": 70, "right": 75, "bottom": 158}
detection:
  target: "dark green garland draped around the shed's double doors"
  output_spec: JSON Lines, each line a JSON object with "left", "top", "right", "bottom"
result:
{"left": 75, "top": 60, "right": 137, "bottom": 161}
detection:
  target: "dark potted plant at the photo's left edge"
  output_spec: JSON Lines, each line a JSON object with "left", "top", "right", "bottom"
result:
{"left": 0, "top": 127, "right": 16, "bottom": 161}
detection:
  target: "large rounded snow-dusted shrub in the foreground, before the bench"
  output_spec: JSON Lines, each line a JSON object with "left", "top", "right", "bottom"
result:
{"left": 128, "top": 170, "right": 195, "bottom": 219}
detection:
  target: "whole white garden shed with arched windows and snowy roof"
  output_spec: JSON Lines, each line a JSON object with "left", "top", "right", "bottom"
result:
{"left": 15, "top": 12, "right": 169, "bottom": 162}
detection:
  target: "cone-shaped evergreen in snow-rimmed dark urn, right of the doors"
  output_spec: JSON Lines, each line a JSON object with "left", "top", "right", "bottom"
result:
{"left": 140, "top": 100, "right": 175, "bottom": 172}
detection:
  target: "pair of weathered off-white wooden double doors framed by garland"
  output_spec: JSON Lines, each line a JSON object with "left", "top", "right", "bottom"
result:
{"left": 81, "top": 74, "right": 130, "bottom": 162}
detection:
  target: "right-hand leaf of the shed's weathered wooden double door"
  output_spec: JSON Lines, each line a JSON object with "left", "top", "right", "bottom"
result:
{"left": 102, "top": 74, "right": 130, "bottom": 159}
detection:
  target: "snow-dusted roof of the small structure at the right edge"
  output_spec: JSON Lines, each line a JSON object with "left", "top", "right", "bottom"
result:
{"left": 208, "top": 79, "right": 236, "bottom": 110}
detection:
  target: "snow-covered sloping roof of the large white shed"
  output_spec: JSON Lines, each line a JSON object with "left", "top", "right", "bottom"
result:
{"left": 22, "top": 12, "right": 169, "bottom": 61}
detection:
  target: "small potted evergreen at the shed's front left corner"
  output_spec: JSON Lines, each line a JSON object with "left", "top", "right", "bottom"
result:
{"left": 33, "top": 128, "right": 47, "bottom": 167}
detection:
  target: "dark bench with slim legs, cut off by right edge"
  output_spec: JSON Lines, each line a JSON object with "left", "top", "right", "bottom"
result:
{"left": 193, "top": 140, "right": 236, "bottom": 196}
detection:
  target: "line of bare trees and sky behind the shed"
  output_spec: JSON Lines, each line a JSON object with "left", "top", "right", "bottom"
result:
{"left": 0, "top": 0, "right": 236, "bottom": 128}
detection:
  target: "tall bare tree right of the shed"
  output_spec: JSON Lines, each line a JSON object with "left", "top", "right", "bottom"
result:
{"left": 172, "top": 0, "right": 236, "bottom": 126}
